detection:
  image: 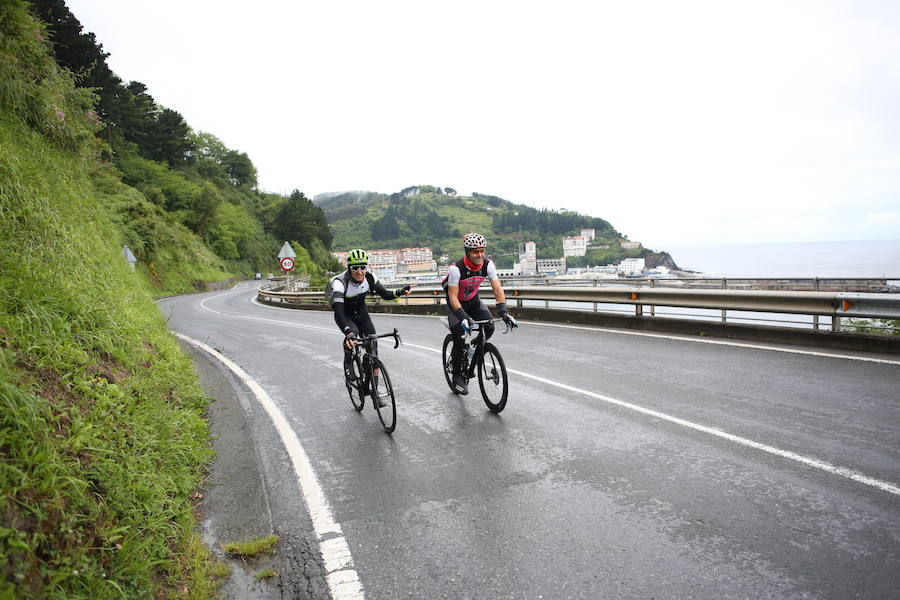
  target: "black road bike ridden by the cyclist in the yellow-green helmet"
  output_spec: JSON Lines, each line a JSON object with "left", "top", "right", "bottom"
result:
{"left": 344, "top": 328, "right": 401, "bottom": 433}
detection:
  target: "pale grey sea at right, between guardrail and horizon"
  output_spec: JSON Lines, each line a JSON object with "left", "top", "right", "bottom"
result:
{"left": 665, "top": 239, "right": 900, "bottom": 280}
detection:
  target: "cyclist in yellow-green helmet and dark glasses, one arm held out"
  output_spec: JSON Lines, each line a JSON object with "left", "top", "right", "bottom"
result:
{"left": 331, "top": 248, "right": 412, "bottom": 390}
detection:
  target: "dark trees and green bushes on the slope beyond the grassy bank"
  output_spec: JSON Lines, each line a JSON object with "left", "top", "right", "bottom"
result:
{"left": 25, "top": 0, "right": 338, "bottom": 296}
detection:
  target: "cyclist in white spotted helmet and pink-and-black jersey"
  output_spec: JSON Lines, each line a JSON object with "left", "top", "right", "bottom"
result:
{"left": 442, "top": 233, "right": 516, "bottom": 395}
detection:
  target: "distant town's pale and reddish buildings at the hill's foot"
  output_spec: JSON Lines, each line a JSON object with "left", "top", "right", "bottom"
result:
{"left": 332, "top": 229, "right": 674, "bottom": 282}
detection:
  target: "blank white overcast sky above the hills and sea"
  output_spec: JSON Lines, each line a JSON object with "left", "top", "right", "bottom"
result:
{"left": 67, "top": 0, "right": 900, "bottom": 249}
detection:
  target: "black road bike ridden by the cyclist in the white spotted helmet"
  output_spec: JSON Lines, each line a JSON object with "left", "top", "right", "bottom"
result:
{"left": 443, "top": 319, "right": 518, "bottom": 413}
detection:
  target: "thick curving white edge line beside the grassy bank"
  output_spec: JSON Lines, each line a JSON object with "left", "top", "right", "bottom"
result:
{"left": 176, "top": 338, "right": 365, "bottom": 600}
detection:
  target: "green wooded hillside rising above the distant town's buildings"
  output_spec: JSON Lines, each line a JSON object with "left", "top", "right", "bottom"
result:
{"left": 316, "top": 185, "right": 653, "bottom": 267}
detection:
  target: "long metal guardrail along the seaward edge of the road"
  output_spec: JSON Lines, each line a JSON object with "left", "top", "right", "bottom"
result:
{"left": 259, "top": 282, "right": 900, "bottom": 331}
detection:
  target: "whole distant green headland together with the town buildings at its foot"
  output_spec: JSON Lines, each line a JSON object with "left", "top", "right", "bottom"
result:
{"left": 313, "top": 185, "right": 677, "bottom": 274}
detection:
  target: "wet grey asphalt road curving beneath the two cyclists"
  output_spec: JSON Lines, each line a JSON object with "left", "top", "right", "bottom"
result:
{"left": 160, "top": 283, "right": 900, "bottom": 599}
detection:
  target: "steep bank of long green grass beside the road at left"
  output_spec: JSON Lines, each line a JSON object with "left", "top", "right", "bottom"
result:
{"left": 0, "top": 0, "right": 222, "bottom": 599}
